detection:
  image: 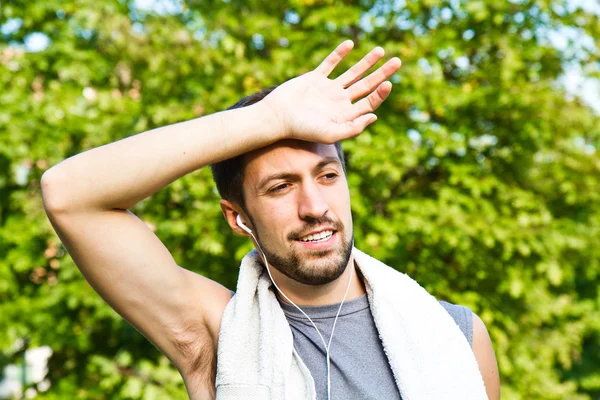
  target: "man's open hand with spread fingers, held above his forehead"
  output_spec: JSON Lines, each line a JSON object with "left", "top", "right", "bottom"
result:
{"left": 263, "top": 40, "right": 401, "bottom": 143}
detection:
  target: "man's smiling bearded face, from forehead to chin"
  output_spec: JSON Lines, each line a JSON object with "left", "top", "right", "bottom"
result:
{"left": 244, "top": 140, "right": 353, "bottom": 285}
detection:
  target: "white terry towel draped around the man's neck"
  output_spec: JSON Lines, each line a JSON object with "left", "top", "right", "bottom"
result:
{"left": 216, "top": 249, "right": 487, "bottom": 400}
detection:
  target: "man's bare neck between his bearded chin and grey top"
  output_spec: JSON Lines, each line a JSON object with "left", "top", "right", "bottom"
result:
{"left": 269, "top": 257, "right": 365, "bottom": 306}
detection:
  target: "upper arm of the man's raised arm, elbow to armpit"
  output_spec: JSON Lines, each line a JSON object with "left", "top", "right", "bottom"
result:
{"left": 48, "top": 210, "right": 231, "bottom": 370}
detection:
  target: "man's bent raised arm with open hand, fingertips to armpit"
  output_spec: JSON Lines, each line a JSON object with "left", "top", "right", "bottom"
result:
{"left": 42, "top": 41, "right": 400, "bottom": 390}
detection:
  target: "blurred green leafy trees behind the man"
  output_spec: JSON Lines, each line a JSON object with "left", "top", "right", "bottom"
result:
{"left": 0, "top": 0, "right": 600, "bottom": 400}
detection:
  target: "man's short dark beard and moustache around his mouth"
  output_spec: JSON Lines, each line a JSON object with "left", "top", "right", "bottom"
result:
{"left": 250, "top": 216, "right": 354, "bottom": 286}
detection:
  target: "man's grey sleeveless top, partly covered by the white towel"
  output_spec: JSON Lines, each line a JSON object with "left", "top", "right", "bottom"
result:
{"left": 279, "top": 294, "right": 473, "bottom": 400}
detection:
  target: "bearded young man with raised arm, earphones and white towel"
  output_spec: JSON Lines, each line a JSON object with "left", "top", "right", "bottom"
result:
{"left": 42, "top": 41, "right": 499, "bottom": 400}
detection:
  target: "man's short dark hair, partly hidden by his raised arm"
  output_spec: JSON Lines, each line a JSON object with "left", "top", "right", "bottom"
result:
{"left": 210, "top": 86, "right": 346, "bottom": 209}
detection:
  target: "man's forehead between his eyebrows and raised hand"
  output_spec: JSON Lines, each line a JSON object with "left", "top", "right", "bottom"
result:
{"left": 244, "top": 140, "right": 339, "bottom": 184}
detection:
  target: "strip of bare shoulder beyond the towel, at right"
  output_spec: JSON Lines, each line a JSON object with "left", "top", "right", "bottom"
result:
{"left": 473, "top": 313, "right": 500, "bottom": 400}
